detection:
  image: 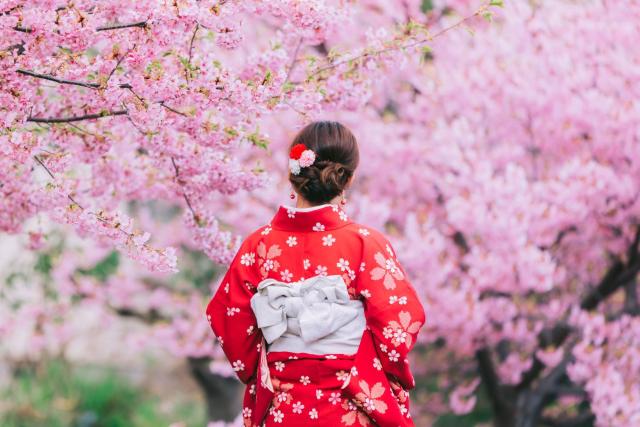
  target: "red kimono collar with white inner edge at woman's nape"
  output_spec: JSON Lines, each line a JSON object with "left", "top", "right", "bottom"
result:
{"left": 271, "top": 203, "right": 351, "bottom": 231}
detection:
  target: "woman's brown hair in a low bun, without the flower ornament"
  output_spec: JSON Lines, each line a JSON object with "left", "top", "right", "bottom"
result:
{"left": 289, "top": 121, "right": 360, "bottom": 204}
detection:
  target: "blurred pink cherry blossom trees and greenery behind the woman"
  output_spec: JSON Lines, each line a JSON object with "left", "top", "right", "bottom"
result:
{"left": 0, "top": 0, "right": 640, "bottom": 427}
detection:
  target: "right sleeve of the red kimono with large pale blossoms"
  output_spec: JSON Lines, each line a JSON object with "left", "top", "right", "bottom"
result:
{"left": 356, "top": 231, "right": 425, "bottom": 390}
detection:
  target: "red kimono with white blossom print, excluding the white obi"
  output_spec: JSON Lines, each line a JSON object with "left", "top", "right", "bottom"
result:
{"left": 207, "top": 204, "right": 425, "bottom": 427}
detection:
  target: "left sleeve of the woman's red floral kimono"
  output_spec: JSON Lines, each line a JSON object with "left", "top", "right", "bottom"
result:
{"left": 206, "top": 240, "right": 262, "bottom": 384}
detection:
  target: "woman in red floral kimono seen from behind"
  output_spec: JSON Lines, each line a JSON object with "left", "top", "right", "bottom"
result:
{"left": 207, "top": 122, "right": 425, "bottom": 427}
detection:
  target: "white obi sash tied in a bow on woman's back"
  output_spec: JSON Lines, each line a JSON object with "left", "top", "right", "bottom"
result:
{"left": 251, "top": 275, "right": 366, "bottom": 354}
